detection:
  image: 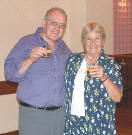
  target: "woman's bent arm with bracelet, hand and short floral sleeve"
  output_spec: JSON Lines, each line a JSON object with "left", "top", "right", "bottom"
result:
{"left": 89, "top": 65, "right": 123, "bottom": 102}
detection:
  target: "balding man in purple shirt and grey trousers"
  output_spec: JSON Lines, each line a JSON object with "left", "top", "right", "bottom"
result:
{"left": 5, "top": 7, "right": 71, "bottom": 135}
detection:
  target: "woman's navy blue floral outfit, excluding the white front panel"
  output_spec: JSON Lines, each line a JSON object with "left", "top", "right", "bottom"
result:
{"left": 64, "top": 50, "right": 122, "bottom": 135}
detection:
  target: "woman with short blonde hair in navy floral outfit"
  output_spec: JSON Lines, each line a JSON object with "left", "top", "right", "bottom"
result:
{"left": 64, "top": 23, "right": 123, "bottom": 135}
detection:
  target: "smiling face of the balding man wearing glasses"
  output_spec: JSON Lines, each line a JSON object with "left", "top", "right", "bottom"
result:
{"left": 43, "top": 11, "right": 66, "bottom": 42}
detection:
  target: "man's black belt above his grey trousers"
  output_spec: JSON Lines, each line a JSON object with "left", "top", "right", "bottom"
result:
{"left": 19, "top": 102, "right": 62, "bottom": 111}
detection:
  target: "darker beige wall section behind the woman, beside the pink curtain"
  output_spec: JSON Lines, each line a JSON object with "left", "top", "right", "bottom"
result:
{"left": 86, "top": 0, "right": 113, "bottom": 54}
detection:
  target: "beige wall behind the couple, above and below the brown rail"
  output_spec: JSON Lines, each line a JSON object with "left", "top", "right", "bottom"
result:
{"left": 0, "top": 0, "right": 113, "bottom": 133}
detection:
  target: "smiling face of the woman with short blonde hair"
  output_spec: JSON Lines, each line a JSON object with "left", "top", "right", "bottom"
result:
{"left": 84, "top": 31, "right": 103, "bottom": 56}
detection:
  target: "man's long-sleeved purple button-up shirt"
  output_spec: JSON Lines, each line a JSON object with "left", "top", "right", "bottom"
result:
{"left": 5, "top": 28, "right": 71, "bottom": 107}
